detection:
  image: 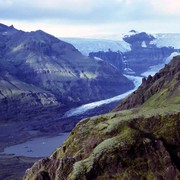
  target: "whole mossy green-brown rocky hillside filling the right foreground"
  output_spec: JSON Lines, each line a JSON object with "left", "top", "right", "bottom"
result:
{"left": 24, "top": 57, "right": 180, "bottom": 180}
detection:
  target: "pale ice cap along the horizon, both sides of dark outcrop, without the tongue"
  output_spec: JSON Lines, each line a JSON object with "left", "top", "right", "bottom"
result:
{"left": 60, "top": 31, "right": 180, "bottom": 56}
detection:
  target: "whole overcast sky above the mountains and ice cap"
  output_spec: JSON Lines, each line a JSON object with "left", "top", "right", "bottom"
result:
{"left": 0, "top": 0, "right": 180, "bottom": 37}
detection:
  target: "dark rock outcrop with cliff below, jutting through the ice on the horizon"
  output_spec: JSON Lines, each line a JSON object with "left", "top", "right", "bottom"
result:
{"left": 123, "top": 32, "right": 175, "bottom": 74}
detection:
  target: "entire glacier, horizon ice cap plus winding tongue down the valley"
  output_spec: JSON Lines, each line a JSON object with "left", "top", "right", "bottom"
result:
{"left": 61, "top": 31, "right": 180, "bottom": 117}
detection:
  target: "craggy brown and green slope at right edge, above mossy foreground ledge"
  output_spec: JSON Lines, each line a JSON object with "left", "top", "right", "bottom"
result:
{"left": 115, "top": 56, "right": 180, "bottom": 111}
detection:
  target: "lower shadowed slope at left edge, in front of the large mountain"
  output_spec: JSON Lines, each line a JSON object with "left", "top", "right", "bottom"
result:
{"left": 0, "top": 72, "right": 61, "bottom": 124}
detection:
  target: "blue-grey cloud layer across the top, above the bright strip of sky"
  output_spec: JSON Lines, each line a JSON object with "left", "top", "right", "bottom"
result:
{"left": 0, "top": 0, "right": 165, "bottom": 24}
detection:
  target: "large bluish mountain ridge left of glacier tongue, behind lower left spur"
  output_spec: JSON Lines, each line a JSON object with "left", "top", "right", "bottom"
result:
{"left": 0, "top": 25, "right": 133, "bottom": 120}
